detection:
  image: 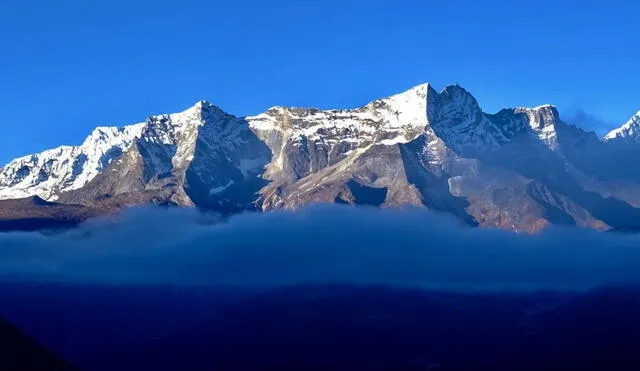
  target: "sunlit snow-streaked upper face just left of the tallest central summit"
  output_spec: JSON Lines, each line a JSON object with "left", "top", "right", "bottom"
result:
{"left": 246, "top": 84, "right": 432, "bottom": 181}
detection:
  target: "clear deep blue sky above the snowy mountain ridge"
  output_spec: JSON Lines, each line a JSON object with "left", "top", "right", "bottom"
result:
{"left": 0, "top": 0, "right": 640, "bottom": 163}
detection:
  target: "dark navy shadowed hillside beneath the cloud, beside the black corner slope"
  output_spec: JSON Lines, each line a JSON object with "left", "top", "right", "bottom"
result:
{"left": 0, "top": 285, "right": 640, "bottom": 371}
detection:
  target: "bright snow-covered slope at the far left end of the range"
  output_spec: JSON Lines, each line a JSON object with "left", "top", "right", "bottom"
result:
{"left": 0, "top": 124, "right": 144, "bottom": 200}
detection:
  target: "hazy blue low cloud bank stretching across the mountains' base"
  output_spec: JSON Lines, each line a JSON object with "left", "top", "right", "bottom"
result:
{"left": 0, "top": 205, "right": 640, "bottom": 289}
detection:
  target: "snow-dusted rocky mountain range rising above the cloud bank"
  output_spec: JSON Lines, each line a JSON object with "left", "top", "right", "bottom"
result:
{"left": 0, "top": 84, "right": 640, "bottom": 232}
